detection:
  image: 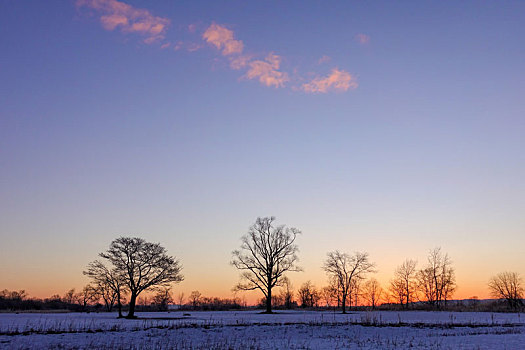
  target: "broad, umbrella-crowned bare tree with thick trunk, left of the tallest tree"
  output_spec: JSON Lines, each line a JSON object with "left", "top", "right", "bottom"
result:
{"left": 96, "top": 237, "right": 184, "bottom": 318}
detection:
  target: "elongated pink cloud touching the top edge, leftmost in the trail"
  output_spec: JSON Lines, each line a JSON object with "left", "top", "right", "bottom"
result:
{"left": 76, "top": 0, "right": 170, "bottom": 44}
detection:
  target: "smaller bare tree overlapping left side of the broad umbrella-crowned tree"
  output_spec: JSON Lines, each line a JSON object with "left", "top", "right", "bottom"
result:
{"left": 84, "top": 260, "right": 126, "bottom": 318}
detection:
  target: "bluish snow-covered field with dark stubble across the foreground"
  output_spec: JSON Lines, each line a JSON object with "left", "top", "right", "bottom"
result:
{"left": 0, "top": 311, "right": 525, "bottom": 349}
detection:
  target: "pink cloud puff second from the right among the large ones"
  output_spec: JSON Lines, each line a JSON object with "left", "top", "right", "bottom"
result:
{"left": 243, "top": 53, "right": 290, "bottom": 88}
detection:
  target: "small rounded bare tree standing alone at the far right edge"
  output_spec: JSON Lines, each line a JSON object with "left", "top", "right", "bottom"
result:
{"left": 489, "top": 272, "right": 524, "bottom": 310}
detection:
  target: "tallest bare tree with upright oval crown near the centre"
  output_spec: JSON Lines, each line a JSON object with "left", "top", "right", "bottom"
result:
{"left": 231, "top": 216, "right": 301, "bottom": 313}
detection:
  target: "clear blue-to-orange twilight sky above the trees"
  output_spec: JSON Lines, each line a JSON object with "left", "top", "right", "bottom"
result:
{"left": 0, "top": 0, "right": 525, "bottom": 300}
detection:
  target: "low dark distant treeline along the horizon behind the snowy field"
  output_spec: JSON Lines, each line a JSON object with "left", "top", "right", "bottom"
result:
{"left": 0, "top": 288, "right": 515, "bottom": 312}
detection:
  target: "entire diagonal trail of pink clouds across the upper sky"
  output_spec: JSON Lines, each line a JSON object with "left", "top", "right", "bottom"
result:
{"left": 76, "top": 0, "right": 356, "bottom": 93}
